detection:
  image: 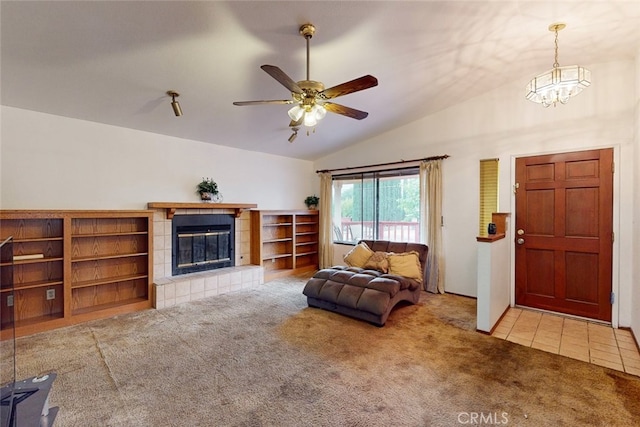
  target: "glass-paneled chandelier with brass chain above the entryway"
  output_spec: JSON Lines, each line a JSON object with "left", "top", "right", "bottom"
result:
{"left": 527, "top": 23, "right": 591, "bottom": 107}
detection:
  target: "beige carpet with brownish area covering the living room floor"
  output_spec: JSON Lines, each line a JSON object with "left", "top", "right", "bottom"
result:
{"left": 5, "top": 278, "right": 640, "bottom": 427}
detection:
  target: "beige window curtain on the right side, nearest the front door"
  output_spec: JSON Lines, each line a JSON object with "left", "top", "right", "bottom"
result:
{"left": 420, "top": 159, "right": 444, "bottom": 294}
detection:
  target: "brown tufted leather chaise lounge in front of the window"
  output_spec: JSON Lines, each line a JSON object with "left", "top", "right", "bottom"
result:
{"left": 302, "top": 240, "right": 428, "bottom": 326}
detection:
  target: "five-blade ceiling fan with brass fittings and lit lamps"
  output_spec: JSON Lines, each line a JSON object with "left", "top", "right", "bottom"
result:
{"left": 233, "top": 24, "right": 378, "bottom": 142}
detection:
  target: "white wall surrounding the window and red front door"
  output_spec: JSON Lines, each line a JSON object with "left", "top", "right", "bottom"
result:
{"left": 315, "top": 60, "right": 639, "bottom": 326}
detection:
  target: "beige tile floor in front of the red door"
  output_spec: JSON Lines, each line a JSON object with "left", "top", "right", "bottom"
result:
{"left": 492, "top": 308, "right": 640, "bottom": 376}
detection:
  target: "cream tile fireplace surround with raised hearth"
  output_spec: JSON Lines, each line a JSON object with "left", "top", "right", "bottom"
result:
{"left": 149, "top": 203, "right": 264, "bottom": 309}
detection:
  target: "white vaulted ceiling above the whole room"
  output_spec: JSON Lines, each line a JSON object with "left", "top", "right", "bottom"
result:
{"left": 0, "top": 0, "right": 640, "bottom": 160}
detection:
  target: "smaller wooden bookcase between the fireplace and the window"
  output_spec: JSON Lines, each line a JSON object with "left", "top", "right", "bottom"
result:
{"left": 251, "top": 210, "right": 319, "bottom": 281}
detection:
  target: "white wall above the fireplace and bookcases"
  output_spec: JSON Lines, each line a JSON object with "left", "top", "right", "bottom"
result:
{"left": 0, "top": 106, "right": 319, "bottom": 209}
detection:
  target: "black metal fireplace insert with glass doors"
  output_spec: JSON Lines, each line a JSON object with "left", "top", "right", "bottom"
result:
{"left": 171, "top": 214, "right": 235, "bottom": 276}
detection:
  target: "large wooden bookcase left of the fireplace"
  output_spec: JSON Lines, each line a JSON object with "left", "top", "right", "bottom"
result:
{"left": 0, "top": 210, "right": 153, "bottom": 338}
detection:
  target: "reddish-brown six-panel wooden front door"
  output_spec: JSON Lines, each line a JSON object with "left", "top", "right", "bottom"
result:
{"left": 515, "top": 149, "right": 613, "bottom": 321}
